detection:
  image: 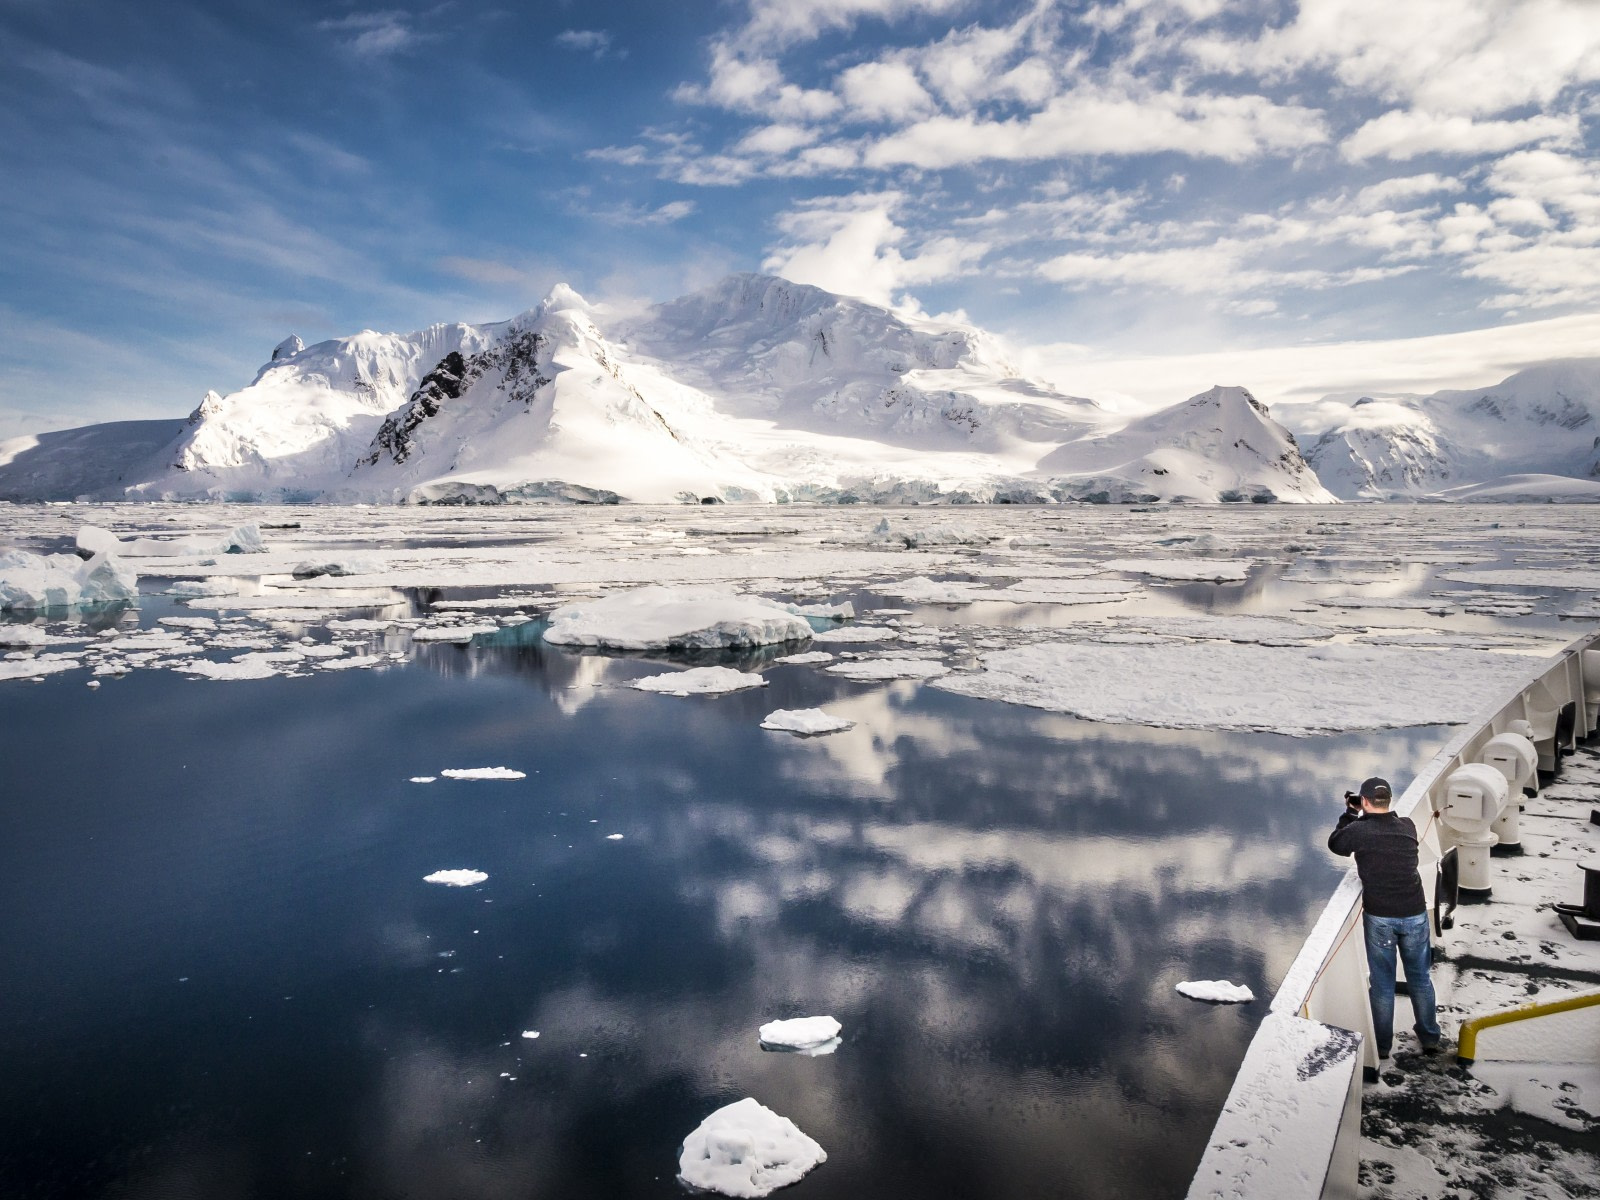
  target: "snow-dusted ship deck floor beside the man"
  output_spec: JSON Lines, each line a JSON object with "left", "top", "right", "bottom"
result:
{"left": 1360, "top": 744, "right": 1600, "bottom": 1200}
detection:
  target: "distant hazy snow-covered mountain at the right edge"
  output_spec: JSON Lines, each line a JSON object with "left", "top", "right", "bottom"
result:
{"left": 1306, "top": 358, "right": 1600, "bottom": 499}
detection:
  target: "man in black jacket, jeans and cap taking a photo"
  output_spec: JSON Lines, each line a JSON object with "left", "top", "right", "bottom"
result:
{"left": 1328, "top": 778, "right": 1442, "bottom": 1059}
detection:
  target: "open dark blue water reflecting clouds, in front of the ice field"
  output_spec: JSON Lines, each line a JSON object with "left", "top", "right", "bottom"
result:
{"left": 0, "top": 637, "right": 1443, "bottom": 1200}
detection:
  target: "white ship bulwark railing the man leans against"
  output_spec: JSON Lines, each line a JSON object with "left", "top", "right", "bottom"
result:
{"left": 1189, "top": 634, "right": 1600, "bottom": 1200}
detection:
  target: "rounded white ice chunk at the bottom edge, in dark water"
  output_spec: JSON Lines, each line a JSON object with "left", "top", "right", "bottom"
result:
{"left": 678, "top": 1096, "right": 827, "bottom": 1198}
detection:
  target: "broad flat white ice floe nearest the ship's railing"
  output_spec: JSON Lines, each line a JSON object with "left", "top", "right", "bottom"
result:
{"left": 934, "top": 642, "right": 1538, "bottom": 736}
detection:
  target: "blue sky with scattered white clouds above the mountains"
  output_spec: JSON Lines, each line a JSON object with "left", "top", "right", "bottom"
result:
{"left": 0, "top": 0, "right": 1600, "bottom": 437}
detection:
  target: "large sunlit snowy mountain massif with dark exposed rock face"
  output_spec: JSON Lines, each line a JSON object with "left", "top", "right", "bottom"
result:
{"left": 0, "top": 275, "right": 1331, "bottom": 502}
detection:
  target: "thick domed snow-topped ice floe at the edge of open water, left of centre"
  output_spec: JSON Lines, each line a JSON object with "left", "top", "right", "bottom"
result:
{"left": 544, "top": 584, "right": 811, "bottom": 650}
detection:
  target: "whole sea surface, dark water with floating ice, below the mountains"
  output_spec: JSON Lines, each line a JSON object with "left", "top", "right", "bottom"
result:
{"left": 0, "top": 504, "right": 1600, "bottom": 1200}
